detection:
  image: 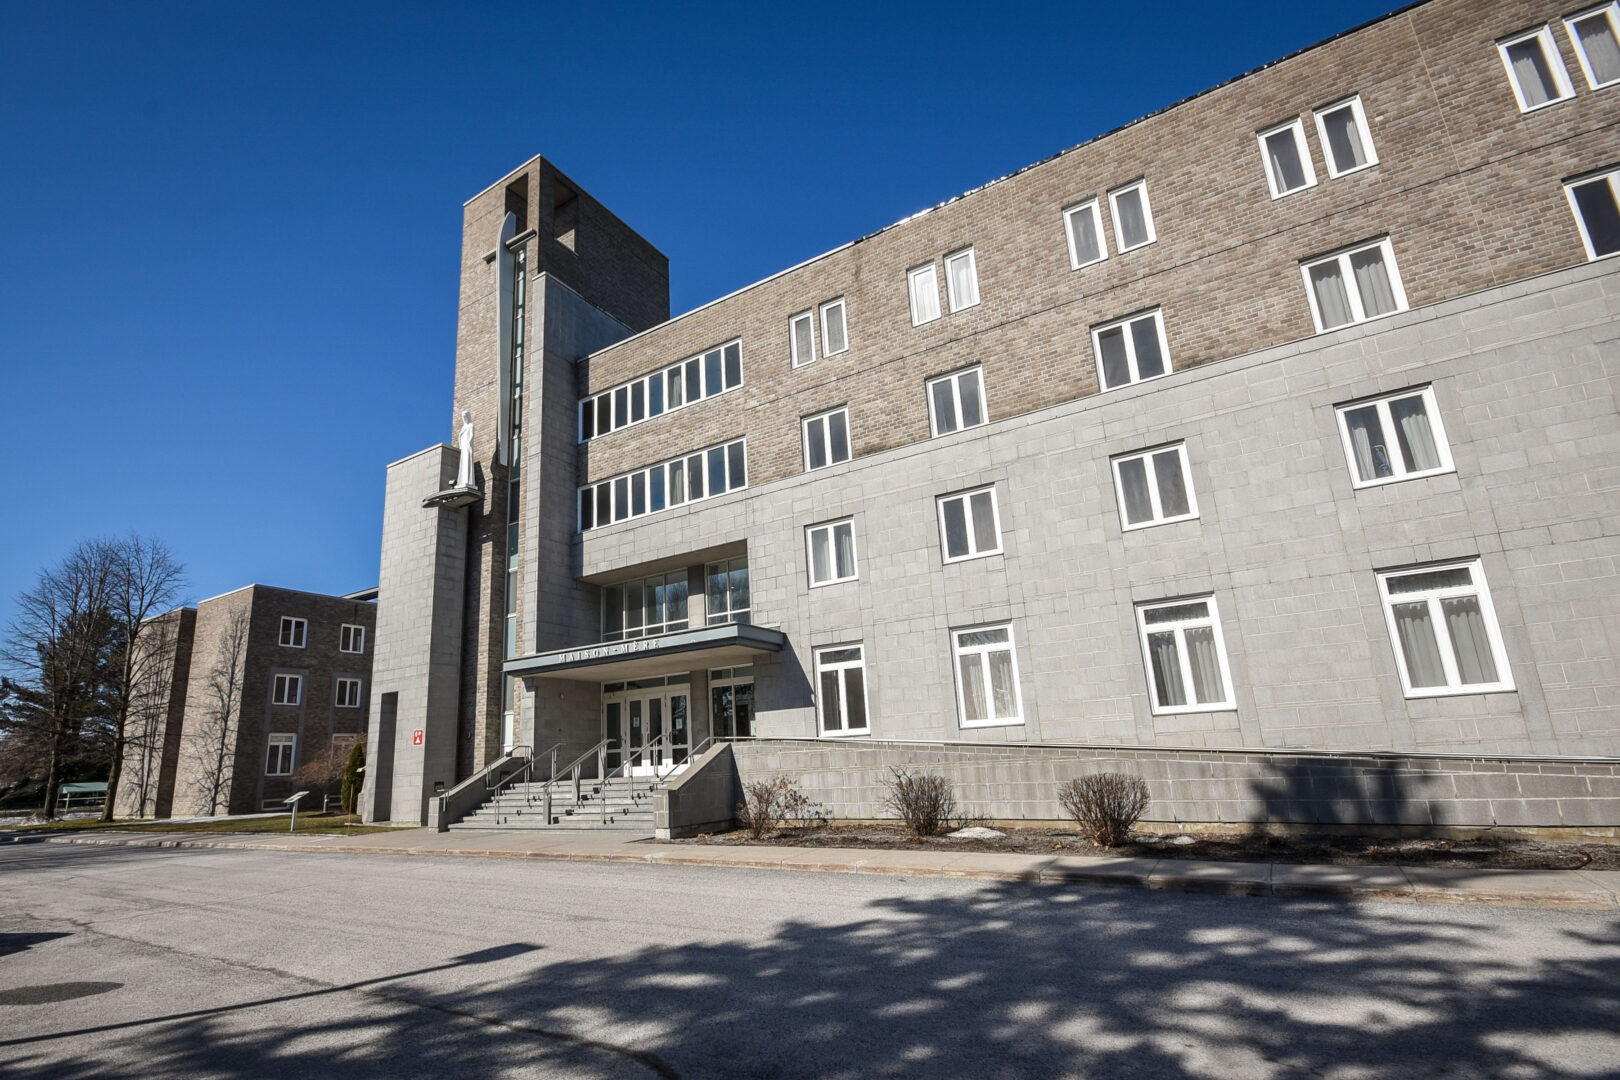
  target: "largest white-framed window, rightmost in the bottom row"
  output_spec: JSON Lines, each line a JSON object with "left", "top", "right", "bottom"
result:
{"left": 1379, "top": 559, "right": 1513, "bottom": 698}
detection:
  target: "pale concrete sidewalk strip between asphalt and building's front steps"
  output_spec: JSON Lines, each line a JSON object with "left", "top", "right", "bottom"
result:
{"left": 15, "top": 829, "right": 1620, "bottom": 910}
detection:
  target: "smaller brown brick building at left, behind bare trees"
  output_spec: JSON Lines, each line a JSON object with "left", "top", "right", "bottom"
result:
{"left": 117, "top": 585, "right": 377, "bottom": 818}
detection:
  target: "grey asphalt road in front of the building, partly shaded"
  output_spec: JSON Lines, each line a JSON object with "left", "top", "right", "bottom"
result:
{"left": 0, "top": 844, "right": 1620, "bottom": 1080}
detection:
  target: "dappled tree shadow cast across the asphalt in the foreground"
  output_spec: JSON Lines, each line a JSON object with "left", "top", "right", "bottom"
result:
{"left": 0, "top": 879, "right": 1620, "bottom": 1080}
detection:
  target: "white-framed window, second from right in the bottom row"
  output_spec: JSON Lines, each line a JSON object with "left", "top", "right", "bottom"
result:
{"left": 1136, "top": 596, "right": 1236, "bottom": 714}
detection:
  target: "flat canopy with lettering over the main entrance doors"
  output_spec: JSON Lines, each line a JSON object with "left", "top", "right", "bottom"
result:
{"left": 502, "top": 622, "right": 787, "bottom": 683}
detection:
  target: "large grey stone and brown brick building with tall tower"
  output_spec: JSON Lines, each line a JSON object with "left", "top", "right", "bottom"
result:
{"left": 366, "top": 0, "right": 1620, "bottom": 831}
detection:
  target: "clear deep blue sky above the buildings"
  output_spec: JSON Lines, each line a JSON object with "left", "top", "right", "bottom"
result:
{"left": 0, "top": 0, "right": 1396, "bottom": 625}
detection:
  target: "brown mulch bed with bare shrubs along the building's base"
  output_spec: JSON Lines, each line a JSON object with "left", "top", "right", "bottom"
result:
{"left": 671, "top": 824, "right": 1620, "bottom": 870}
